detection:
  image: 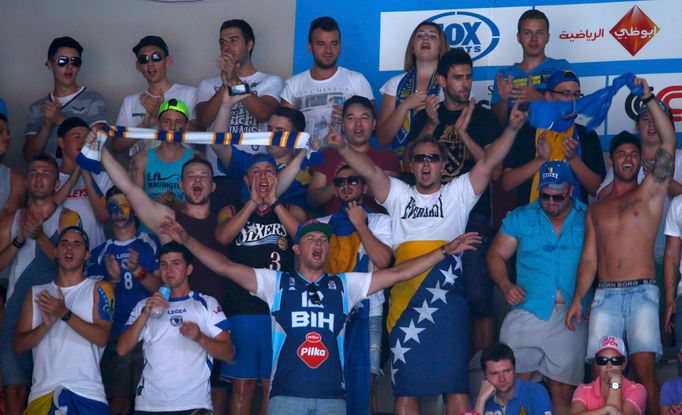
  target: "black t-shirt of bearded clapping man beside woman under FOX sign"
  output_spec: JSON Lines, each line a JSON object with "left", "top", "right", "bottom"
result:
{"left": 408, "top": 103, "right": 501, "bottom": 218}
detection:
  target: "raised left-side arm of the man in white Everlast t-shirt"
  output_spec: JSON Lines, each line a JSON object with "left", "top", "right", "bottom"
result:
{"left": 324, "top": 125, "right": 391, "bottom": 203}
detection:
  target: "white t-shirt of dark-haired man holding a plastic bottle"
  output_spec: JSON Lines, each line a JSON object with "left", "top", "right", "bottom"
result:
{"left": 126, "top": 291, "right": 230, "bottom": 412}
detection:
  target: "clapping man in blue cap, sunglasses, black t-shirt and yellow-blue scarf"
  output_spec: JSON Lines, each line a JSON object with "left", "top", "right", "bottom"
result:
{"left": 502, "top": 70, "right": 606, "bottom": 211}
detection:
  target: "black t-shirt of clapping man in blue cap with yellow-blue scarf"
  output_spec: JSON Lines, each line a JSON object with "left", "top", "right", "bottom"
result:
{"left": 504, "top": 124, "right": 606, "bottom": 206}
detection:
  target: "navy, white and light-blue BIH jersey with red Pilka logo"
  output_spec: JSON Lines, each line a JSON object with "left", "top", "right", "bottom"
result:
{"left": 255, "top": 269, "right": 372, "bottom": 399}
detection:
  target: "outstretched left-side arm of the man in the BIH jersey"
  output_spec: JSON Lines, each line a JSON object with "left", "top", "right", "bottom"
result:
{"left": 160, "top": 216, "right": 258, "bottom": 293}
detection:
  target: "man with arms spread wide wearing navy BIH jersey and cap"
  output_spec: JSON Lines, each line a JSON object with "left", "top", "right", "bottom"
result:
{"left": 162, "top": 217, "right": 480, "bottom": 415}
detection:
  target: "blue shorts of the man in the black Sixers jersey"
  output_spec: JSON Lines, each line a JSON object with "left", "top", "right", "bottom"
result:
{"left": 220, "top": 314, "right": 272, "bottom": 380}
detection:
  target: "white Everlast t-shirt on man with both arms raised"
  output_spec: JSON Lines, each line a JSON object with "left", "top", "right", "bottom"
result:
{"left": 377, "top": 173, "right": 480, "bottom": 250}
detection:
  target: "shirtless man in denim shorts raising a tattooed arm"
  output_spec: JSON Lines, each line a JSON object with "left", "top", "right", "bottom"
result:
{"left": 566, "top": 78, "right": 676, "bottom": 415}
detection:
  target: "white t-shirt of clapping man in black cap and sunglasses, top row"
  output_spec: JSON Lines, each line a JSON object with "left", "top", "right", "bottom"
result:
{"left": 116, "top": 84, "right": 197, "bottom": 157}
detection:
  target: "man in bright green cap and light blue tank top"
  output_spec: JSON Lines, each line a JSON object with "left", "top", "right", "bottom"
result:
{"left": 129, "top": 98, "right": 195, "bottom": 213}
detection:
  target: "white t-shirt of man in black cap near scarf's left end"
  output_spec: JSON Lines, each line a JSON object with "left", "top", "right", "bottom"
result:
{"left": 59, "top": 171, "right": 114, "bottom": 248}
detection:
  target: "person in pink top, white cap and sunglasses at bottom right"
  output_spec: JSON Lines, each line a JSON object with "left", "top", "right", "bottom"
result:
{"left": 571, "top": 335, "right": 648, "bottom": 415}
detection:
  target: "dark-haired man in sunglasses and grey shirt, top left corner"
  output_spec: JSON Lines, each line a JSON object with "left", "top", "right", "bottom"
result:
{"left": 23, "top": 36, "right": 107, "bottom": 162}
